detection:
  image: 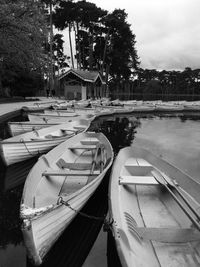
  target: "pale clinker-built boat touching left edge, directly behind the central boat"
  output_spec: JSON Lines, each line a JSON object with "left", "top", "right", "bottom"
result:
{"left": 0, "top": 120, "right": 90, "bottom": 166}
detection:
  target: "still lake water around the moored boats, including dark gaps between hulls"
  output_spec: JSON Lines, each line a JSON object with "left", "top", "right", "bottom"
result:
{"left": 0, "top": 114, "right": 200, "bottom": 267}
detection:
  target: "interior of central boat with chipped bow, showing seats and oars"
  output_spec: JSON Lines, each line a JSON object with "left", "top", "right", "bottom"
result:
{"left": 34, "top": 138, "right": 111, "bottom": 208}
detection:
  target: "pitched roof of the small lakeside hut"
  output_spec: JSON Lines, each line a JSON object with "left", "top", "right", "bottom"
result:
{"left": 58, "top": 69, "right": 105, "bottom": 83}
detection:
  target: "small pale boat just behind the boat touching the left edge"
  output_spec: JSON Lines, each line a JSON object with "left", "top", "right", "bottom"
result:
{"left": 8, "top": 121, "right": 59, "bottom": 136}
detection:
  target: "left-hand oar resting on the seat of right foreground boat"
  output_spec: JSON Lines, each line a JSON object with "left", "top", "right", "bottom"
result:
{"left": 151, "top": 170, "right": 200, "bottom": 231}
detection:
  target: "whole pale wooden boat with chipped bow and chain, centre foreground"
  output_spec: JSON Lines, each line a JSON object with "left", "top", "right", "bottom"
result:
{"left": 20, "top": 132, "right": 113, "bottom": 265}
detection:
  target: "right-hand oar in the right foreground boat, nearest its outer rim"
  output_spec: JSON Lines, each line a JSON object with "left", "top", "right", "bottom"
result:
{"left": 162, "top": 174, "right": 200, "bottom": 221}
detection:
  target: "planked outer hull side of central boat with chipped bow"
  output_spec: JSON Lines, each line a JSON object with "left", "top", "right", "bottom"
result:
{"left": 22, "top": 172, "right": 103, "bottom": 265}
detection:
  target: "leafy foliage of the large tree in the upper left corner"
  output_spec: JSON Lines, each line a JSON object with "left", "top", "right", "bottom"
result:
{"left": 0, "top": 0, "right": 47, "bottom": 94}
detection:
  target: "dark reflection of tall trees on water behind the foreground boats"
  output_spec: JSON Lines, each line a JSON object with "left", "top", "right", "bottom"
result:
{"left": 91, "top": 117, "right": 140, "bottom": 154}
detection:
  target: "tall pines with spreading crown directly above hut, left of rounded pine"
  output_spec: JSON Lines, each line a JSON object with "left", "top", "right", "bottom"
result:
{"left": 53, "top": 1, "right": 107, "bottom": 69}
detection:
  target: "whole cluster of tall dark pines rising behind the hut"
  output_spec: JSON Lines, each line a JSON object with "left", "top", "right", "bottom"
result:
{"left": 53, "top": 0, "right": 139, "bottom": 81}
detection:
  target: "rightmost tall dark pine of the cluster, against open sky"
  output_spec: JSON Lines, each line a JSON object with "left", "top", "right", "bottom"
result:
{"left": 105, "top": 9, "right": 139, "bottom": 81}
